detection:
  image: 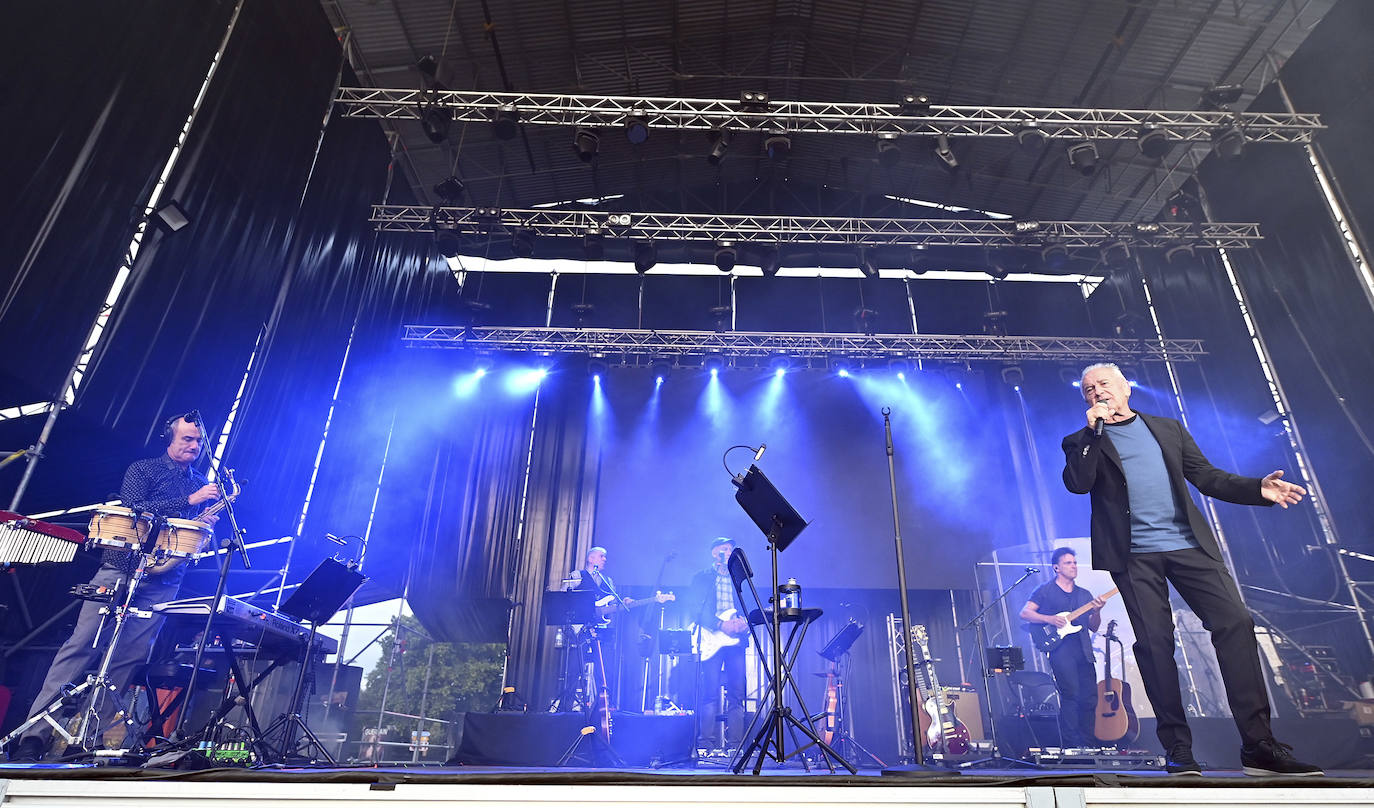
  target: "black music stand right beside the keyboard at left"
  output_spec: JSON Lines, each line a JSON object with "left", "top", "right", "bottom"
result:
{"left": 262, "top": 558, "right": 367, "bottom": 765}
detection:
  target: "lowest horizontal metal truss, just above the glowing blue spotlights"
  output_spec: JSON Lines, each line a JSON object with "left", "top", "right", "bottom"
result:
{"left": 403, "top": 326, "right": 1206, "bottom": 364}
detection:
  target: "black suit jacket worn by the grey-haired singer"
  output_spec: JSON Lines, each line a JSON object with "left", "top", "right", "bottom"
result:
{"left": 1062, "top": 412, "right": 1274, "bottom": 572}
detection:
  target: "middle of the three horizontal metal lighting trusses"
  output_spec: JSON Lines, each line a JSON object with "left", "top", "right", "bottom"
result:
{"left": 370, "top": 205, "right": 1263, "bottom": 249}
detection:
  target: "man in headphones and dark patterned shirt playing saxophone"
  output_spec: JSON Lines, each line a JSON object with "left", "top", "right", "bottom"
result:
{"left": 10, "top": 415, "right": 220, "bottom": 760}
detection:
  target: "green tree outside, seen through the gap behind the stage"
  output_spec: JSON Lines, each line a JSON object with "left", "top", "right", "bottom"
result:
{"left": 349, "top": 616, "right": 506, "bottom": 759}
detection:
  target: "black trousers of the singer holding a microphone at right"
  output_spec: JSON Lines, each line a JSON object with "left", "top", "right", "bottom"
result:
{"left": 1112, "top": 550, "right": 1272, "bottom": 752}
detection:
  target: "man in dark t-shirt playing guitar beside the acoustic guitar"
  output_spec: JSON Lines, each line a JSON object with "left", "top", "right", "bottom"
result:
{"left": 1021, "top": 547, "right": 1105, "bottom": 748}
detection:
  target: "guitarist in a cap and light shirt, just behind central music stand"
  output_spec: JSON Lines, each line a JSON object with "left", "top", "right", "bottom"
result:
{"left": 688, "top": 536, "right": 749, "bottom": 749}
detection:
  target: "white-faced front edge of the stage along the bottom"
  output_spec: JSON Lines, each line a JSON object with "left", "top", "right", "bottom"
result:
{"left": 0, "top": 764, "right": 1374, "bottom": 808}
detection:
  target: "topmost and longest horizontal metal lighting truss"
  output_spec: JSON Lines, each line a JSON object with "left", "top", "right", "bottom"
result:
{"left": 335, "top": 87, "right": 1325, "bottom": 143}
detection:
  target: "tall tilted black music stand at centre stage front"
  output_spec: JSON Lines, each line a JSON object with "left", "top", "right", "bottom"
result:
{"left": 731, "top": 466, "right": 856, "bottom": 774}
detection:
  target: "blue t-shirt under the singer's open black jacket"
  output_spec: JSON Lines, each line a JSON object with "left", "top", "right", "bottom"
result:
{"left": 1107, "top": 416, "right": 1198, "bottom": 552}
